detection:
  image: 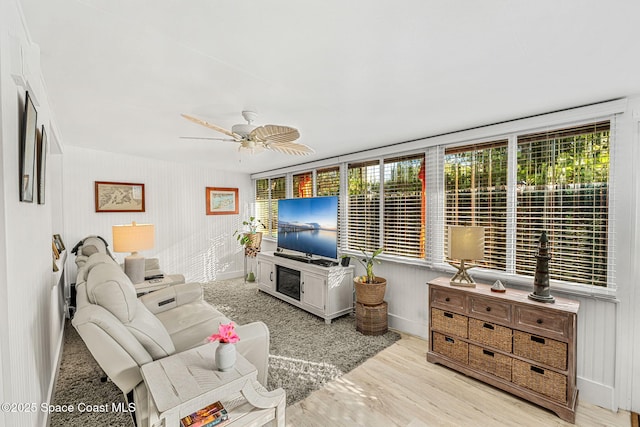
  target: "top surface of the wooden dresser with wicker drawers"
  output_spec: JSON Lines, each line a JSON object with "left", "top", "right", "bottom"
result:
{"left": 428, "top": 277, "right": 580, "bottom": 313}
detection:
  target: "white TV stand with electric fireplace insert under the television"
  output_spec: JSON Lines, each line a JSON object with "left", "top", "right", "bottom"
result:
{"left": 257, "top": 252, "right": 354, "bottom": 324}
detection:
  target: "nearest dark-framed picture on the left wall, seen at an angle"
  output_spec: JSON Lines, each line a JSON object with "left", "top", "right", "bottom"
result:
{"left": 19, "top": 91, "right": 38, "bottom": 203}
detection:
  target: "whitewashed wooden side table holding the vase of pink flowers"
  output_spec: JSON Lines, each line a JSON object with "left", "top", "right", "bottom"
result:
{"left": 141, "top": 342, "right": 286, "bottom": 427}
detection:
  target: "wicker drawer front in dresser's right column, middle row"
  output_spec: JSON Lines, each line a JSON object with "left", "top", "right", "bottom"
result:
{"left": 513, "top": 331, "right": 567, "bottom": 369}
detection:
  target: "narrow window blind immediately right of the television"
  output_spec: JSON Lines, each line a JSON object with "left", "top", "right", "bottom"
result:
{"left": 347, "top": 160, "right": 381, "bottom": 251}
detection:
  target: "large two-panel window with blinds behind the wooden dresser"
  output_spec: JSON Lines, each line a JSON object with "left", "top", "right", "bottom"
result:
{"left": 444, "top": 121, "right": 610, "bottom": 286}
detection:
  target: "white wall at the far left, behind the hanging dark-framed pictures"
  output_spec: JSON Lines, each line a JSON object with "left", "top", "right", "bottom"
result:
{"left": 0, "top": 1, "right": 63, "bottom": 426}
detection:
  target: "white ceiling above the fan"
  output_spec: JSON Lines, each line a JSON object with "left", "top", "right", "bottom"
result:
{"left": 20, "top": 0, "right": 640, "bottom": 172}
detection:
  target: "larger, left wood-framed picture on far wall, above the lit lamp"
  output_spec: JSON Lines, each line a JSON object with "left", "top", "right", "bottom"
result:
{"left": 95, "top": 181, "right": 144, "bottom": 212}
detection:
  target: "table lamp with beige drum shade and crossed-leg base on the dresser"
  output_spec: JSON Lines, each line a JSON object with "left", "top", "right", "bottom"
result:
{"left": 448, "top": 225, "right": 484, "bottom": 288}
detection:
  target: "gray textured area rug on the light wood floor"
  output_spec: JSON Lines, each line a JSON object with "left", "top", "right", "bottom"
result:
{"left": 51, "top": 279, "right": 400, "bottom": 427}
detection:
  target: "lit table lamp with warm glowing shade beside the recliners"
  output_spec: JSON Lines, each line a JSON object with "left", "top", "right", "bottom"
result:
{"left": 111, "top": 222, "right": 154, "bottom": 284}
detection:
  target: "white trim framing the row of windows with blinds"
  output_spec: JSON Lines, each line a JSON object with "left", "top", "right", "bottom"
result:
{"left": 251, "top": 99, "right": 628, "bottom": 299}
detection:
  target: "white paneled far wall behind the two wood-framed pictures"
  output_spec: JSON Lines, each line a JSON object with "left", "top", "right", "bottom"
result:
{"left": 63, "top": 147, "right": 253, "bottom": 282}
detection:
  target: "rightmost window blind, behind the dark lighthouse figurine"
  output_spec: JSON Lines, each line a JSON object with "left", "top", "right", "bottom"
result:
{"left": 516, "top": 121, "right": 610, "bottom": 286}
